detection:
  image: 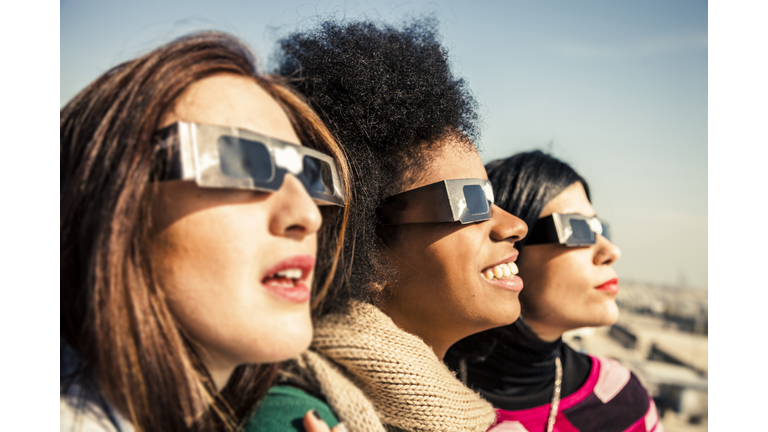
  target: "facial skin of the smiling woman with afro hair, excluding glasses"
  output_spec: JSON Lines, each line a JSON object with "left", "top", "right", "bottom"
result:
{"left": 380, "top": 142, "right": 528, "bottom": 360}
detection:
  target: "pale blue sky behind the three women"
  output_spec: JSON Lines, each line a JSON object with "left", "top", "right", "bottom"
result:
{"left": 60, "top": 0, "right": 708, "bottom": 288}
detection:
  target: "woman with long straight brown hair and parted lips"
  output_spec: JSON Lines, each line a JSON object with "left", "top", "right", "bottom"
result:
{"left": 60, "top": 32, "right": 349, "bottom": 431}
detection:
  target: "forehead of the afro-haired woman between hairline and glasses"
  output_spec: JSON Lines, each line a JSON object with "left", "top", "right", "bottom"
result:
{"left": 400, "top": 138, "right": 488, "bottom": 192}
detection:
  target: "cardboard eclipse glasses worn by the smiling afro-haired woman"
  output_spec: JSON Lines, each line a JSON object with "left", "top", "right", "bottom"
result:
{"left": 377, "top": 179, "right": 493, "bottom": 225}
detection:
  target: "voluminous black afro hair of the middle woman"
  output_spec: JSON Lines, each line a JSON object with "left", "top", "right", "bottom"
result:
{"left": 277, "top": 18, "right": 479, "bottom": 314}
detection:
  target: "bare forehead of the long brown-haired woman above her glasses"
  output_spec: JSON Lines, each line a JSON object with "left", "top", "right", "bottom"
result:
{"left": 161, "top": 74, "right": 300, "bottom": 144}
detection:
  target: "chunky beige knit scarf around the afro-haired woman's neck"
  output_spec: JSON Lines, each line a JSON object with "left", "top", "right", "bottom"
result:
{"left": 280, "top": 302, "right": 496, "bottom": 432}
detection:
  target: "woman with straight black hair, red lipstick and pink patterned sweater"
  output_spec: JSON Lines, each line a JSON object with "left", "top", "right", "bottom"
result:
{"left": 445, "top": 151, "right": 663, "bottom": 432}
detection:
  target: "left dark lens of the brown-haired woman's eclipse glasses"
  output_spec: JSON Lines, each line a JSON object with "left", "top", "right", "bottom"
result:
{"left": 218, "top": 136, "right": 273, "bottom": 181}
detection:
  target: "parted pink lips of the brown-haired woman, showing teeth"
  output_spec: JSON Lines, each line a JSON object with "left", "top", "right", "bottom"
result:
{"left": 261, "top": 255, "right": 315, "bottom": 303}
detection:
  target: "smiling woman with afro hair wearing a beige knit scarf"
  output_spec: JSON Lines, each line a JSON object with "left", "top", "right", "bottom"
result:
{"left": 246, "top": 19, "right": 527, "bottom": 431}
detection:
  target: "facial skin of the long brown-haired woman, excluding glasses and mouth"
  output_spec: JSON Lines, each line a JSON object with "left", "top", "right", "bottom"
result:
{"left": 149, "top": 74, "right": 322, "bottom": 389}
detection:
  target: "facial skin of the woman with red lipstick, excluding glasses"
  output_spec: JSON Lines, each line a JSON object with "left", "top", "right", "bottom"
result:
{"left": 518, "top": 182, "right": 621, "bottom": 341}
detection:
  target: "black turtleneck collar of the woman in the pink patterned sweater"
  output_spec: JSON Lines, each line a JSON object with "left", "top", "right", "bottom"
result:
{"left": 445, "top": 320, "right": 592, "bottom": 411}
